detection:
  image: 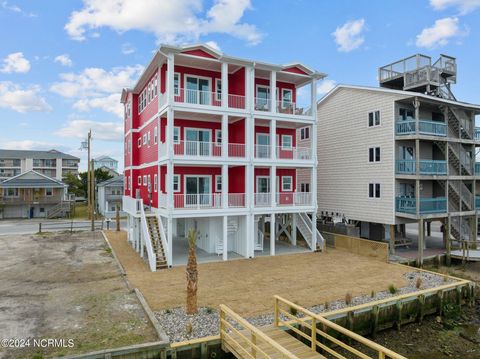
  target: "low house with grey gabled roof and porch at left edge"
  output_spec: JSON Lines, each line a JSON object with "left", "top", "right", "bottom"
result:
{"left": 0, "top": 170, "right": 70, "bottom": 219}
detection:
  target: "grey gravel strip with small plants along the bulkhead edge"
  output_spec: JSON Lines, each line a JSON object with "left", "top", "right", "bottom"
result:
{"left": 155, "top": 272, "right": 455, "bottom": 342}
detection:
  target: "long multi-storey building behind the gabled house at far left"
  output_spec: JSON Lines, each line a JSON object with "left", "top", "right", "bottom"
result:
{"left": 0, "top": 149, "right": 80, "bottom": 180}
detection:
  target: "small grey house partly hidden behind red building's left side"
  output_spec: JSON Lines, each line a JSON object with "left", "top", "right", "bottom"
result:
{"left": 97, "top": 175, "right": 124, "bottom": 217}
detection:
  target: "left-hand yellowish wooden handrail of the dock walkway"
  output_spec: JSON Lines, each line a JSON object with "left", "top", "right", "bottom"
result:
{"left": 220, "top": 304, "right": 299, "bottom": 359}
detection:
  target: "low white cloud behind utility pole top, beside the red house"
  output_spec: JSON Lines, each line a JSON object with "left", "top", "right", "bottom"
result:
{"left": 55, "top": 119, "right": 123, "bottom": 142}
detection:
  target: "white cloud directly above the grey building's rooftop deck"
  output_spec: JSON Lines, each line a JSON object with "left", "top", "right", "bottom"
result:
{"left": 415, "top": 17, "right": 465, "bottom": 49}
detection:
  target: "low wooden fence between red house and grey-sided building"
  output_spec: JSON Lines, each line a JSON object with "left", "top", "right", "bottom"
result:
{"left": 322, "top": 232, "right": 388, "bottom": 262}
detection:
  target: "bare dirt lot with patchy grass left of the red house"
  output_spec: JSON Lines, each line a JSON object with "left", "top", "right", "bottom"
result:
{"left": 0, "top": 232, "right": 157, "bottom": 358}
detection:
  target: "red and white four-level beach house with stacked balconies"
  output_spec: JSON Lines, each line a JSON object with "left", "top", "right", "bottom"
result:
{"left": 122, "top": 45, "right": 325, "bottom": 266}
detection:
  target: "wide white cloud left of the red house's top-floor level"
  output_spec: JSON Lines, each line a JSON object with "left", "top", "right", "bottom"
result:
{"left": 50, "top": 65, "right": 143, "bottom": 98}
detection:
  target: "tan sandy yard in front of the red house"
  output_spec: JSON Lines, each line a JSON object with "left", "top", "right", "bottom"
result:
{"left": 107, "top": 232, "right": 412, "bottom": 316}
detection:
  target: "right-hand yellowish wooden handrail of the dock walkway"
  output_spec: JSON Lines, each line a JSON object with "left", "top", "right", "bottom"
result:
{"left": 274, "top": 295, "right": 407, "bottom": 359}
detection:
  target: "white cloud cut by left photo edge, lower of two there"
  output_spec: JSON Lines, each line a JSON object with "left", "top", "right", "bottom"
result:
{"left": 0, "top": 82, "right": 52, "bottom": 113}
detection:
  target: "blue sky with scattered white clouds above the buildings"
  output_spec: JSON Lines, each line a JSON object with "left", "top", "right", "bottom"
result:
{"left": 0, "top": 0, "right": 480, "bottom": 169}
